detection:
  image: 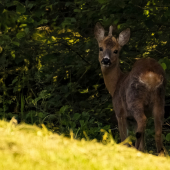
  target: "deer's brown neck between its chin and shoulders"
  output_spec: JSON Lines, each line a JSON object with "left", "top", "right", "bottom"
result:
{"left": 101, "top": 65, "right": 123, "bottom": 97}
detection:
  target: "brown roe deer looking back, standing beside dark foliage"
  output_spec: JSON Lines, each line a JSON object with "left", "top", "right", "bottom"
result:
{"left": 94, "top": 23, "right": 165, "bottom": 155}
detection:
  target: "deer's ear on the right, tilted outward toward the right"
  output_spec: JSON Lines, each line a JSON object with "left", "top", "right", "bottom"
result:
{"left": 118, "top": 28, "right": 130, "bottom": 46}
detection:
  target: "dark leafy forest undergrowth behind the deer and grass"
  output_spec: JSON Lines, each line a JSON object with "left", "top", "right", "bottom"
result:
{"left": 0, "top": 0, "right": 170, "bottom": 151}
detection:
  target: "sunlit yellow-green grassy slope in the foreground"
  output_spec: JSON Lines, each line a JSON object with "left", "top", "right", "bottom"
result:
{"left": 0, "top": 121, "right": 170, "bottom": 170}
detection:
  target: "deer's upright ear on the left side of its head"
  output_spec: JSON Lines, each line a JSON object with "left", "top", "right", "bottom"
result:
{"left": 94, "top": 22, "right": 105, "bottom": 42}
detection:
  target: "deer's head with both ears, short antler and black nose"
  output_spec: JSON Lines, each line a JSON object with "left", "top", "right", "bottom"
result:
{"left": 94, "top": 23, "right": 130, "bottom": 67}
